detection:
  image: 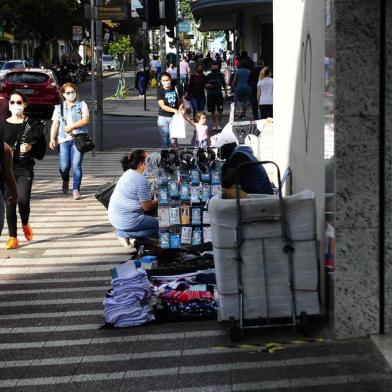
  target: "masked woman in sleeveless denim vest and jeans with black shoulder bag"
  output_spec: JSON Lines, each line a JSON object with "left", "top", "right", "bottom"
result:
{"left": 49, "top": 83, "right": 89, "bottom": 200}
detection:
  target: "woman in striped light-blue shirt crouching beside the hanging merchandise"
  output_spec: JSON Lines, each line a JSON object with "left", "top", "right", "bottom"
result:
{"left": 108, "top": 150, "right": 158, "bottom": 246}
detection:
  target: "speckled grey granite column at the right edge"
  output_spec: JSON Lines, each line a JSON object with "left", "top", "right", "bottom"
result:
{"left": 334, "top": 0, "right": 380, "bottom": 337}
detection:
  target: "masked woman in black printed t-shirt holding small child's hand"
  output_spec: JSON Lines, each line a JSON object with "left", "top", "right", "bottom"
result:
{"left": 157, "top": 72, "right": 183, "bottom": 148}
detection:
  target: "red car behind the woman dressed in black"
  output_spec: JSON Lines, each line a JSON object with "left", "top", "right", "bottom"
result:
{"left": 1, "top": 68, "right": 61, "bottom": 118}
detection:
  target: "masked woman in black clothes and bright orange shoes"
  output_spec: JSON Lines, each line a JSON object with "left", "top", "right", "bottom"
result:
{"left": 0, "top": 92, "right": 46, "bottom": 249}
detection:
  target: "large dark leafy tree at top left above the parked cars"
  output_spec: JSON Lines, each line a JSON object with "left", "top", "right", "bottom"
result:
{"left": 0, "top": 0, "right": 87, "bottom": 65}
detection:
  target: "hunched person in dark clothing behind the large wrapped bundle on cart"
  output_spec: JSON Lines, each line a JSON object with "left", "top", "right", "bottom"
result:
{"left": 215, "top": 131, "right": 273, "bottom": 198}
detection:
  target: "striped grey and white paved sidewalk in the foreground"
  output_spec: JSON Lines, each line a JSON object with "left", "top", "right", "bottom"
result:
{"left": 0, "top": 151, "right": 392, "bottom": 392}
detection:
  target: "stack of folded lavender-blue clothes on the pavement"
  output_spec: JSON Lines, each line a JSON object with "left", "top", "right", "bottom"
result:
{"left": 103, "top": 268, "right": 155, "bottom": 327}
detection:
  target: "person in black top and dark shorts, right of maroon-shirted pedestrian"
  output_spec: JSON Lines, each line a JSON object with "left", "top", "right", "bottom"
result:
{"left": 205, "top": 63, "right": 227, "bottom": 131}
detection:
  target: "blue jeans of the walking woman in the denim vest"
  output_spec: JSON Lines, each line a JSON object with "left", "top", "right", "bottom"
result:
{"left": 59, "top": 140, "right": 84, "bottom": 191}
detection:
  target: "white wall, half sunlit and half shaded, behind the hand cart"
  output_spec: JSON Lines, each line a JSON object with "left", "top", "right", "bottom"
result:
{"left": 273, "top": 0, "right": 325, "bottom": 266}
